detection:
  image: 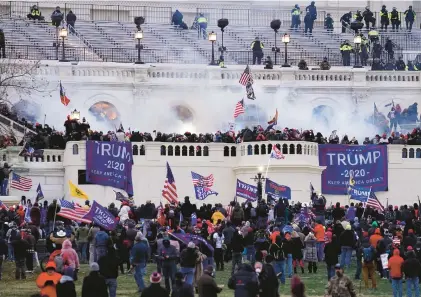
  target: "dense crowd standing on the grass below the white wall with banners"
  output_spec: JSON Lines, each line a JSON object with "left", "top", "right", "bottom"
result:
{"left": 0, "top": 193, "right": 421, "bottom": 297}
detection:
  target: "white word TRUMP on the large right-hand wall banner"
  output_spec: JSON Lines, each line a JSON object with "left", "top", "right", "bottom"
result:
{"left": 326, "top": 151, "right": 381, "bottom": 166}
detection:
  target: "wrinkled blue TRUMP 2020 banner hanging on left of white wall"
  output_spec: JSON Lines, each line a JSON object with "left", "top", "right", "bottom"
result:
{"left": 86, "top": 141, "right": 133, "bottom": 196}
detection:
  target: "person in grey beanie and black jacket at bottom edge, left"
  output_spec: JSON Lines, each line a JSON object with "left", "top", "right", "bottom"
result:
{"left": 82, "top": 262, "right": 108, "bottom": 297}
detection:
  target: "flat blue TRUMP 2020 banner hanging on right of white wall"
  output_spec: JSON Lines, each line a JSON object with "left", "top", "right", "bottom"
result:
{"left": 319, "top": 144, "right": 388, "bottom": 195}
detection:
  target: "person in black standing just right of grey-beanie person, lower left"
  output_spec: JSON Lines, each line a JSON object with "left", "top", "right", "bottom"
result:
{"left": 98, "top": 246, "right": 119, "bottom": 297}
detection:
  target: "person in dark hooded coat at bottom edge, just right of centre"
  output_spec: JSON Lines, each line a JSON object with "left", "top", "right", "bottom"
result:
{"left": 228, "top": 264, "right": 259, "bottom": 297}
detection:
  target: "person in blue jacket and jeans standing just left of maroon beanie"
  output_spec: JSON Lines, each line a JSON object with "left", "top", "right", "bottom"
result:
{"left": 130, "top": 234, "right": 150, "bottom": 292}
